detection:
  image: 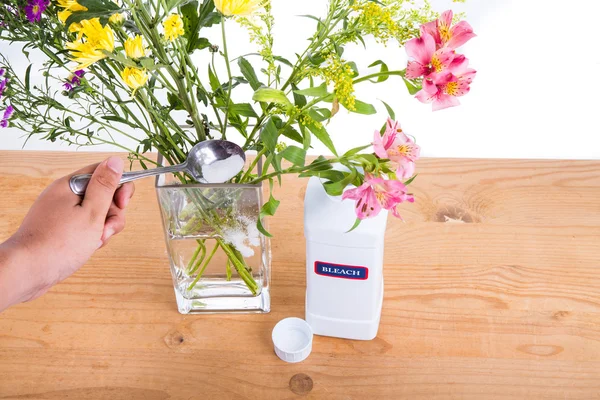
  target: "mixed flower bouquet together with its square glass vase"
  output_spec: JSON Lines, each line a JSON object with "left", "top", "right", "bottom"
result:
{"left": 0, "top": 0, "right": 475, "bottom": 313}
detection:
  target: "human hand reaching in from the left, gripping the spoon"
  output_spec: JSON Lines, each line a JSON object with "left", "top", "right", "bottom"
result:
{"left": 0, "top": 157, "right": 134, "bottom": 311}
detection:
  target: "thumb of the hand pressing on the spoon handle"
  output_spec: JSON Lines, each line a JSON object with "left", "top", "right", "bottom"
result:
{"left": 81, "top": 157, "right": 123, "bottom": 219}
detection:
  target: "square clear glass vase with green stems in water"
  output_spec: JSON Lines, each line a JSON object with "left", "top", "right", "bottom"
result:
{"left": 156, "top": 167, "right": 271, "bottom": 314}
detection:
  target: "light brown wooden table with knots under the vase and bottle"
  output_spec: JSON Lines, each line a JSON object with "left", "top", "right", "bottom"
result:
{"left": 0, "top": 152, "right": 600, "bottom": 400}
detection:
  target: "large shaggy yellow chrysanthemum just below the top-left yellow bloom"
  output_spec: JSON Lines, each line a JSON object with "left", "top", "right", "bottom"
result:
{"left": 67, "top": 18, "right": 115, "bottom": 69}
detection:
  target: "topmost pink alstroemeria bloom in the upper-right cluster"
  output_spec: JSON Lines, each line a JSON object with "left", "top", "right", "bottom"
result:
{"left": 421, "top": 10, "right": 477, "bottom": 49}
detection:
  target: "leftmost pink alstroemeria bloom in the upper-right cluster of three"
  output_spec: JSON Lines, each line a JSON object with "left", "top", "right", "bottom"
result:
{"left": 405, "top": 32, "right": 455, "bottom": 79}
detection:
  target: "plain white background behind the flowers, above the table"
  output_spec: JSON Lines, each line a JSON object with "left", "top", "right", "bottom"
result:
{"left": 0, "top": 0, "right": 600, "bottom": 159}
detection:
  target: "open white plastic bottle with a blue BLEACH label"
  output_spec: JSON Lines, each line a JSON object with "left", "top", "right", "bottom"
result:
{"left": 304, "top": 177, "right": 387, "bottom": 340}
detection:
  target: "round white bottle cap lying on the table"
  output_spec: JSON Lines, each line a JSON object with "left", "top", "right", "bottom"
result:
{"left": 272, "top": 318, "right": 313, "bottom": 363}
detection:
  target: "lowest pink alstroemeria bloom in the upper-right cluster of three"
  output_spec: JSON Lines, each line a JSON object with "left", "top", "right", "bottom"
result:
{"left": 416, "top": 57, "right": 477, "bottom": 111}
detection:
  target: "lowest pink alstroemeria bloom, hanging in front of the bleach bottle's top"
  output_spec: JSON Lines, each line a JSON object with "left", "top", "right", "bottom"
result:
{"left": 342, "top": 174, "right": 415, "bottom": 220}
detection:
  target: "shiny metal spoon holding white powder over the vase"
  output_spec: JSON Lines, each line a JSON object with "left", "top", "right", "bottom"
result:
{"left": 69, "top": 140, "right": 246, "bottom": 196}
